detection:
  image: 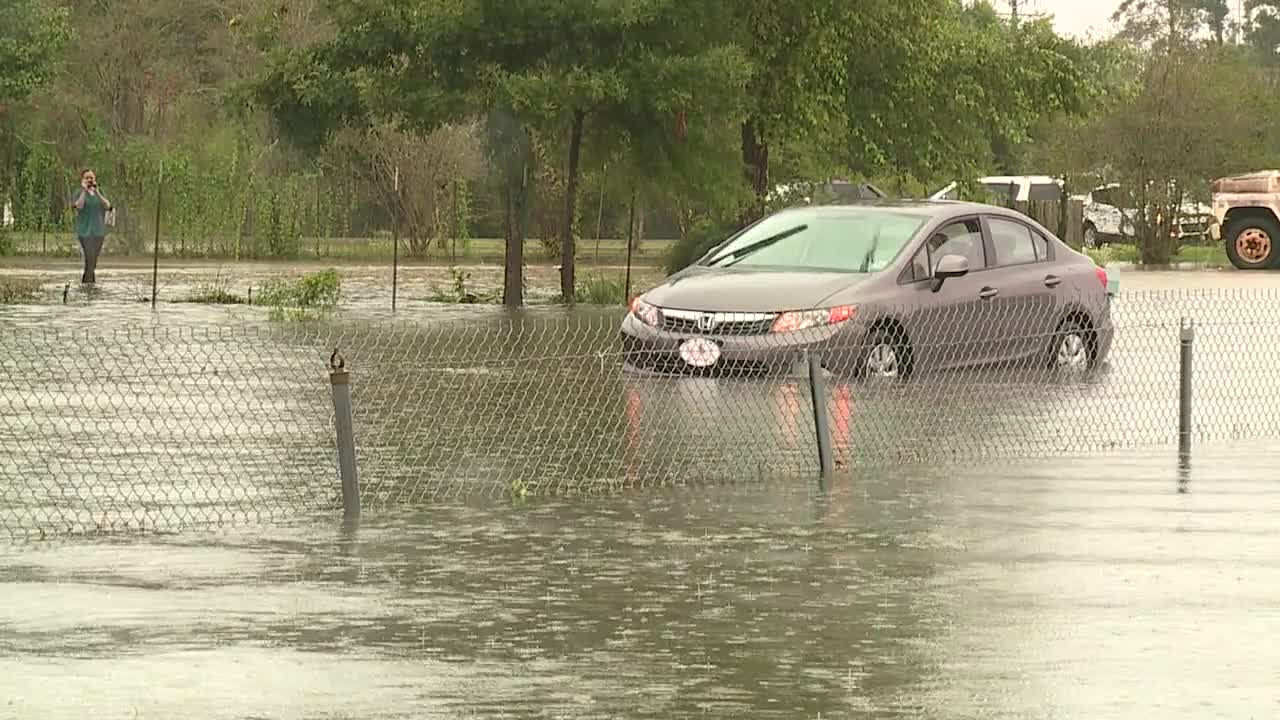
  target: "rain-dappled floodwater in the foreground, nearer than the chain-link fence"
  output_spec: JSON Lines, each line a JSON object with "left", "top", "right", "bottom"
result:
{"left": 0, "top": 446, "right": 1280, "bottom": 720}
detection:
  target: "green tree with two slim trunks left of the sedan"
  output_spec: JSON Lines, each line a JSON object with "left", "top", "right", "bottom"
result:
{"left": 257, "top": 0, "right": 741, "bottom": 304}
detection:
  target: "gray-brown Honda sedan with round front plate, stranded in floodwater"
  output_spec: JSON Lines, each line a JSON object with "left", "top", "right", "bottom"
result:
{"left": 622, "top": 196, "right": 1112, "bottom": 378}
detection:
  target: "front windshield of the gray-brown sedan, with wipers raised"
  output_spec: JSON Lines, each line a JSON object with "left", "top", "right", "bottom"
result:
{"left": 699, "top": 208, "right": 925, "bottom": 273}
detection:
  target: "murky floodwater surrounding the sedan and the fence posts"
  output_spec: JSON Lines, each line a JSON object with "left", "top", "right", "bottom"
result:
{"left": 0, "top": 267, "right": 1280, "bottom": 720}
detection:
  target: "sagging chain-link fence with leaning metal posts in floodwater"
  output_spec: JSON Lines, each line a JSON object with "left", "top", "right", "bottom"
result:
{"left": 0, "top": 291, "right": 1280, "bottom": 536}
